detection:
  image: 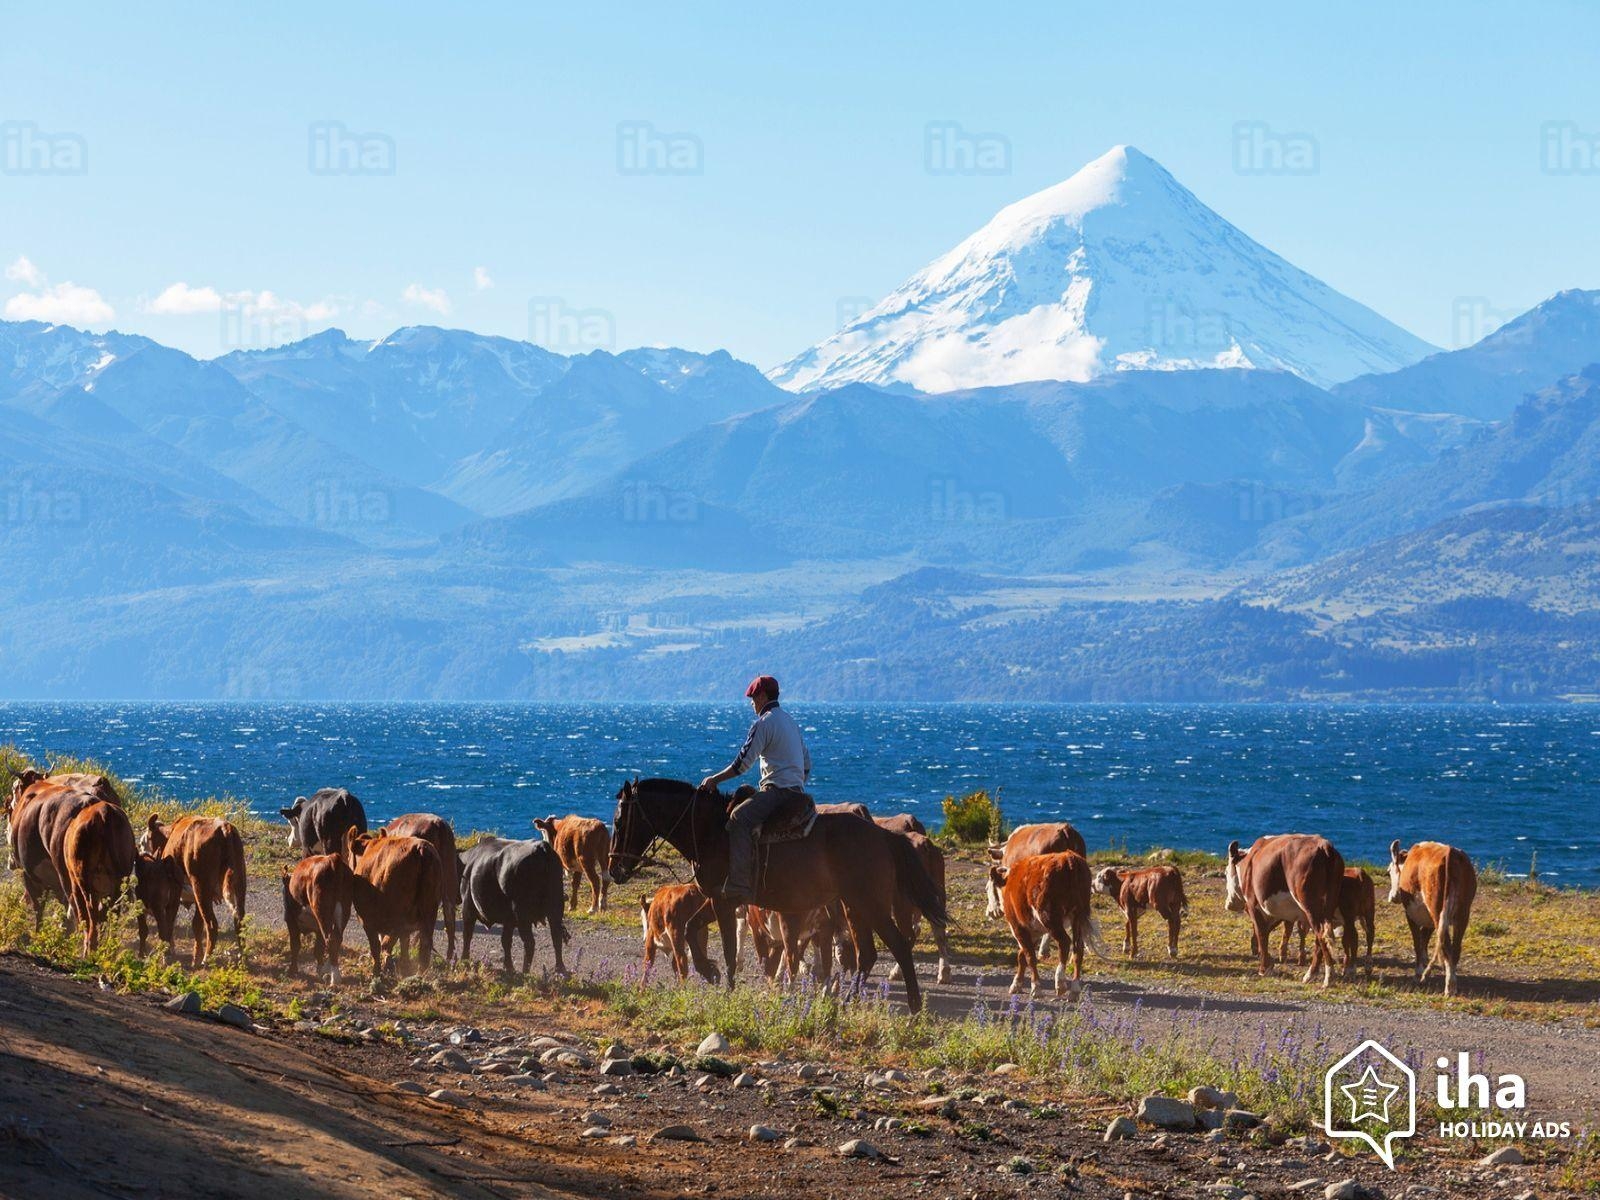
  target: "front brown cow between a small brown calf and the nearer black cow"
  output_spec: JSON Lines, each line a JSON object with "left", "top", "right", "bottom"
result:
{"left": 344, "top": 829, "right": 443, "bottom": 976}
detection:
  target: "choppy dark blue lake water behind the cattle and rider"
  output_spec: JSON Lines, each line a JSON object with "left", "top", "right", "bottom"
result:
{"left": 0, "top": 702, "right": 1600, "bottom": 886}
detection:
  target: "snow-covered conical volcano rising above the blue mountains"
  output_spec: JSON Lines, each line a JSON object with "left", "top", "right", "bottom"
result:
{"left": 771, "top": 146, "right": 1434, "bottom": 392}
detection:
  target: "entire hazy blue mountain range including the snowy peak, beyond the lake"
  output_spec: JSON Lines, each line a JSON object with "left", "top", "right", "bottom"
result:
{"left": 0, "top": 147, "right": 1600, "bottom": 699}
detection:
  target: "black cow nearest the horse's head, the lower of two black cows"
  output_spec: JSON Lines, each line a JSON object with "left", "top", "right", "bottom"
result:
{"left": 461, "top": 837, "right": 571, "bottom": 974}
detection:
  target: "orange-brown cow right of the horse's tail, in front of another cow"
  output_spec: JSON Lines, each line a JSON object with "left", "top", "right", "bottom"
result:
{"left": 989, "top": 850, "right": 1104, "bottom": 1000}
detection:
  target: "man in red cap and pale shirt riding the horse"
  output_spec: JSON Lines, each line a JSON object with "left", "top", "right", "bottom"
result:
{"left": 701, "top": 675, "right": 811, "bottom": 904}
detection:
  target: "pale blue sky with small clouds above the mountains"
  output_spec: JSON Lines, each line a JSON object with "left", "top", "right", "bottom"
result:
{"left": 0, "top": 2, "right": 1600, "bottom": 366}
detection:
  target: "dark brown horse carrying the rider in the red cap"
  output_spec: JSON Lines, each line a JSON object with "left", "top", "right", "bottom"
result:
{"left": 608, "top": 779, "right": 946, "bottom": 1013}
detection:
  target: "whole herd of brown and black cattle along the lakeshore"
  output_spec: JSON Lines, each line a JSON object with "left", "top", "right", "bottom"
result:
{"left": 6, "top": 771, "right": 1477, "bottom": 995}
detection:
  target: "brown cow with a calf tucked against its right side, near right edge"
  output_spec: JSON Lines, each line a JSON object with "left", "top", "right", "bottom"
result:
{"left": 1226, "top": 834, "right": 1344, "bottom": 987}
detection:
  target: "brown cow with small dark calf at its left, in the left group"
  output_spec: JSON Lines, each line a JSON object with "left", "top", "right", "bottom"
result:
{"left": 141, "top": 813, "right": 248, "bottom": 966}
